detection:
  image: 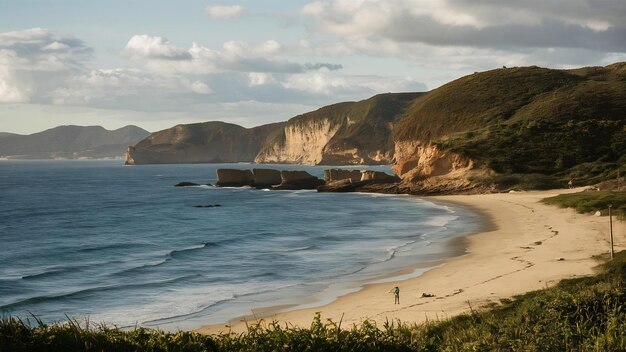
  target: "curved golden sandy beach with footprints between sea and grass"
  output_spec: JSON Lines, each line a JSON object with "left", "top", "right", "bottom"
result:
{"left": 198, "top": 189, "right": 626, "bottom": 333}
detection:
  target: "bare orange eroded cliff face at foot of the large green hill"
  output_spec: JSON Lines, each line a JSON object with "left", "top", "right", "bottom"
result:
{"left": 392, "top": 140, "right": 490, "bottom": 194}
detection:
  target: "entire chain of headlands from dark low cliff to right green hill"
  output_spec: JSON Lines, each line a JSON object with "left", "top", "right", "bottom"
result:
{"left": 127, "top": 63, "right": 626, "bottom": 194}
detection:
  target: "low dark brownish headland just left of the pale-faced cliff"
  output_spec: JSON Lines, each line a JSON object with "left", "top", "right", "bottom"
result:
{"left": 126, "top": 121, "right": 283, "bottom": 165}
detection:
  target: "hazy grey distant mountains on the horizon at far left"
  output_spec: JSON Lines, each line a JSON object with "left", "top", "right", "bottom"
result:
{"left": 0, "top": 126, "right": 150, "bottom": 159}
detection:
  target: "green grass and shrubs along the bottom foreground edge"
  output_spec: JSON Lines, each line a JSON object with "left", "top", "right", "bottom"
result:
{"left": 0, "top": 251, "right": 626, "bottom": 351}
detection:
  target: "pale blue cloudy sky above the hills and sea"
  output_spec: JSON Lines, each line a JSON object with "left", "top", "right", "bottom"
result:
{"left": 0, "top": 0, "right": 626, "bottom": 134}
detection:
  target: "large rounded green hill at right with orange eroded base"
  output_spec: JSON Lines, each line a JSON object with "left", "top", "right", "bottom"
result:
{"left": 393, "top": 63, "right": 626, "bottom": 193}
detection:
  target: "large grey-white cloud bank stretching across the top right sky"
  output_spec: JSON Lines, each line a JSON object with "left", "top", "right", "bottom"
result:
{"left": 301, "top": 0, "right": 626, "bottom": 52}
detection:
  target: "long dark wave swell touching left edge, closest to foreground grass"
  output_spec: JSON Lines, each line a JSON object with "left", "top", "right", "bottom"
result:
{"left": 0, "top": 274, "right": 200, "bottom": 310}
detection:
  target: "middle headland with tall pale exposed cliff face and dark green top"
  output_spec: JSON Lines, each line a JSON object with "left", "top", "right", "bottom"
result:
{"left": 255, "top": 93, "right": 421, "bottom": 165}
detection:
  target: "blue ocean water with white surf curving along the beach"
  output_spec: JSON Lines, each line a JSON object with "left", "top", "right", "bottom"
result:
{"left": 0, "top": 160, "right": 481, "bottom": 330}
